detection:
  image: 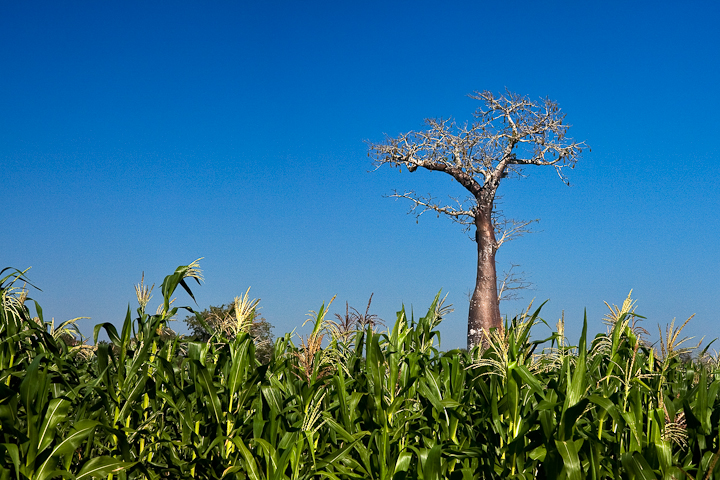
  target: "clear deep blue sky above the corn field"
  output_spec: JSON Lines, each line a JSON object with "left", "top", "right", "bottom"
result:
{"left": 0, "top": 1, "right": 720, "bottom": 348}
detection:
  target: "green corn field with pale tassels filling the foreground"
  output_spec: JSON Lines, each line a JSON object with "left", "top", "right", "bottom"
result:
{"left": 0, "top": 264, "right": 720, "bottom": 480}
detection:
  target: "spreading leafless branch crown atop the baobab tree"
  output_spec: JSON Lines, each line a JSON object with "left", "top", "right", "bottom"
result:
{"left": 368, "top": 91, "right": 587, "bottom": 205}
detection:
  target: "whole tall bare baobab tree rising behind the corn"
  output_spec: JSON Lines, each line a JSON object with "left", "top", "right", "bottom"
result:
{"left": 369, "top": 91, "right": 587, "bottom": 350}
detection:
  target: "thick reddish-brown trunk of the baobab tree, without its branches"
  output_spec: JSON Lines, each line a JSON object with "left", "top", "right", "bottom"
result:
{"left": 467, "top": 201, "right": 502, "bottom": 351}
